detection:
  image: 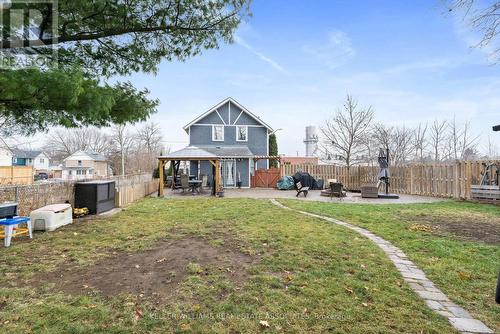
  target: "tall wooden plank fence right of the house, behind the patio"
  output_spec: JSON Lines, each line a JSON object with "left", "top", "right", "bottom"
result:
{"left": 281, "top": 160, "right": 500, "bottom": 199}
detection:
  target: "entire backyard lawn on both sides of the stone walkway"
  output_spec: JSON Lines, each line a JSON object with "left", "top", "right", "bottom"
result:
{"left": 0, "top": 198, "right": 500, "bottom": 333}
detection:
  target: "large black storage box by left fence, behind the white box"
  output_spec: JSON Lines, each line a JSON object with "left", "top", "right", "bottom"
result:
{"left": 75, "top": 181, "right": 115, "bottom": 215}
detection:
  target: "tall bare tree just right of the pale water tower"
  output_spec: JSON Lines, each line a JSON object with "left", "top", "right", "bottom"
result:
{"left": 320, "top": 94, "right": 373, "bottom": 170}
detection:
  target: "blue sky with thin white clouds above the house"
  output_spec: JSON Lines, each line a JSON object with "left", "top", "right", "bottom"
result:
{"left": 48, "top": 0, "right": 500, "bottom": 155}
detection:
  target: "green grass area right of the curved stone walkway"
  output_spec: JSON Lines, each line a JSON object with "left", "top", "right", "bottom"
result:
{"left": 280, "top": 200, "right": 500, "bottom": 331}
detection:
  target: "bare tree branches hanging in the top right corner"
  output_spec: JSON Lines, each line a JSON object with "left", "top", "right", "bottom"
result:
{"left": 446, "top": 0, "right": 500, "bottom": 63}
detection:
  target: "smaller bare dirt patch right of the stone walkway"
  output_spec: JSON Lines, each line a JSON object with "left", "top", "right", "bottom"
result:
{"left": 412, "top": 215, "right": 500, "bottom": 245}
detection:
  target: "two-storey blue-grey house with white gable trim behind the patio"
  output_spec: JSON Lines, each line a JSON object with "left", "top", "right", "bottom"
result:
{"left": 172, "top": 98, "right": 273, "bottom": 188}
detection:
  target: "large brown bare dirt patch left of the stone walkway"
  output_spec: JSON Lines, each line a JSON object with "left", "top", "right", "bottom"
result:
{"left": 34, "top": 236, "right": 258, "bottom": 301}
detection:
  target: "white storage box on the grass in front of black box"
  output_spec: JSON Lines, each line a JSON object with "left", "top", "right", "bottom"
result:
{"left": 30, "top": 204, "right": 73, "bottom": 231}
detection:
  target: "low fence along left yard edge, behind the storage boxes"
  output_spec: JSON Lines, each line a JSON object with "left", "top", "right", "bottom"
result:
{"left": 0, "top": 173, "right": 159, "bottom": 215}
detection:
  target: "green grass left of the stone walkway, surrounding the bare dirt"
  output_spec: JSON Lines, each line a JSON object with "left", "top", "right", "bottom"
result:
{"left": 0, "top": 198, "right": 458, "bottom": 333}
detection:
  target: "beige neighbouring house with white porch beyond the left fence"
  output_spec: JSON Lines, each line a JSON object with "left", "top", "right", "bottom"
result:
{"left": 61, "top": 151, "right": 109, "bottom": 180}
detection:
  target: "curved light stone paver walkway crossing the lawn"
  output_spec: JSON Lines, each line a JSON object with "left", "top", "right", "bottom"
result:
{"left": 271, "top": 199, "right": 493, "bottom": 333}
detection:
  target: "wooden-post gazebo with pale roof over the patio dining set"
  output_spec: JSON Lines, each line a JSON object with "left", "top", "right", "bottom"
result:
{"left": 158, "top": 146, "right": 221, "bottom": 197}
